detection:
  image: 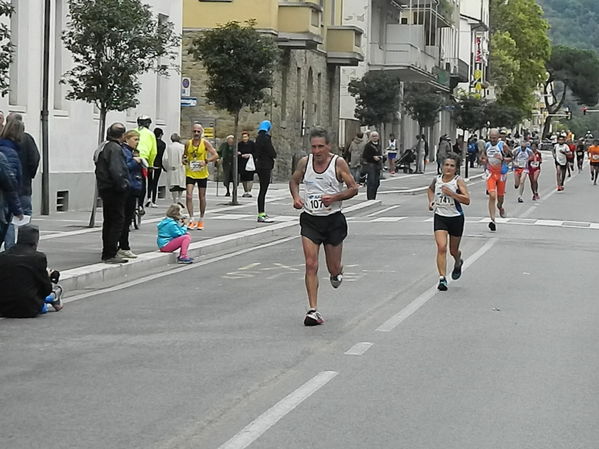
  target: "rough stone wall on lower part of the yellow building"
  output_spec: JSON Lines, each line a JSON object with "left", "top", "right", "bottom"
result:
{"left": 181, "top": 31, "right": 340, "bottom": 181}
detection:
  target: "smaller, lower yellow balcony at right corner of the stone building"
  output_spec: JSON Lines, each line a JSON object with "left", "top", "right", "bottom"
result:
{"left": 327, "top": 26, "right": 364, "bottom": 66}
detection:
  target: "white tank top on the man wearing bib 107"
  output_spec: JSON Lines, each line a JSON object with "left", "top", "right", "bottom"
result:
{"left": 304, "top": 154, "right": 343, "bottom": 216}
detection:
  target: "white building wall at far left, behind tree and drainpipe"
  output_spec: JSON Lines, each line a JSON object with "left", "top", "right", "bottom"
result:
{"left": 0, "top": 0, "right": 182, "bottom": 213}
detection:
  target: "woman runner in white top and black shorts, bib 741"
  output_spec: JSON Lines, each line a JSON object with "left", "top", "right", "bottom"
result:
{"left": 427, "top": 155, "right": 470, "bottom": 291}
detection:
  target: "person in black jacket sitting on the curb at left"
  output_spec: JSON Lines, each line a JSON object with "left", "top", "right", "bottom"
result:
{"left": 0, "top": 225, "right": 62, "bottom": 318}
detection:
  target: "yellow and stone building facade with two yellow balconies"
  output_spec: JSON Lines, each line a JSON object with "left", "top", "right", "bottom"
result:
{"left": 181, "top": 0, "right": 363, "bottom": 180}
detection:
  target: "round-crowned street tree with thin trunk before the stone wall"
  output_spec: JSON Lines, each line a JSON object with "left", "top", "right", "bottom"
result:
{"left": 189, "top": 21, "right": 279, "bottom": 204}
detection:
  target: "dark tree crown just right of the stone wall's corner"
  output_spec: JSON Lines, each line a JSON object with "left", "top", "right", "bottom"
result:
{"left": 348, "top": 70, "right": 401, "bottom": 126}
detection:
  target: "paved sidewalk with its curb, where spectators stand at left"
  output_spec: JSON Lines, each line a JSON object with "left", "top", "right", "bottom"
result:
{"left": 33, "top": 163, "right": 481, "bottom": 292}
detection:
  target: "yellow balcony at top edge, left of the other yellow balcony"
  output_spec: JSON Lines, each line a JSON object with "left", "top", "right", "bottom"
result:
{"left": 277, "top": 1, "right": 323, "bottom": 50}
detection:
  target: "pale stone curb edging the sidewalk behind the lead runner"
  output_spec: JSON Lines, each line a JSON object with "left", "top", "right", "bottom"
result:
{"left": 60, "top": 200, "right": 381, "bottom": 292}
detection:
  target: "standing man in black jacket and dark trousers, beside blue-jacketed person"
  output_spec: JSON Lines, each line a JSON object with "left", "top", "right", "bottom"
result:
{"left": 96, "top": 123, "right": 129, "bottom": 263}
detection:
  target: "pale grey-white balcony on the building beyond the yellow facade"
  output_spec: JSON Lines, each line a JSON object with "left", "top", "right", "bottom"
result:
{"left": 370, "top": 24, "right": 439, "bottom": 82}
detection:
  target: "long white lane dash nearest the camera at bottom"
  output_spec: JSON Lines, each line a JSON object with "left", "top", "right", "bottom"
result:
{"left": 218, "top": 371, "right": 339, "bottom": 449}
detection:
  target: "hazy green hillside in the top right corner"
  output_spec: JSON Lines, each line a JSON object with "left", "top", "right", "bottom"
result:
{"left": 537, "top": 0, "right": 599, "bottom": 51}
